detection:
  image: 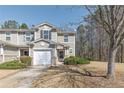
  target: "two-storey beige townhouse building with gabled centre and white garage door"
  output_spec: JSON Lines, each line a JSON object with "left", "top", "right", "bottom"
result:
{"left": 0, "top": 23, "right": 75, "bottom": 65}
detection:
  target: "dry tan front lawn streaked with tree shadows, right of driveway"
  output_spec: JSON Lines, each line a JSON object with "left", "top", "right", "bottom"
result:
{"left": 33, "top": 63, "right": 124, "bottom": 88}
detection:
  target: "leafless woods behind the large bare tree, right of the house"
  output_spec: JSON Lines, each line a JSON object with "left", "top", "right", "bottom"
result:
{"left": 76, "top": 11, "right": 124, "bottom": 63}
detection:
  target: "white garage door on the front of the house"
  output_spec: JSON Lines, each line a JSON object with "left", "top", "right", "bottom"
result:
{"left": 33, "top": 50, "right": 51, "bottom": 65}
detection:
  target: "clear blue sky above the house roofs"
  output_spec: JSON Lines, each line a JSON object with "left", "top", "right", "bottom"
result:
{"left": 0, "top": 5, "right": 88, "bottom": 27}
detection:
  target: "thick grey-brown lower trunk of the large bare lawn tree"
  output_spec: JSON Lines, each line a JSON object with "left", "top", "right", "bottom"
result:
{"left": 107, "top": 47, "right": 118, "bottom": 80}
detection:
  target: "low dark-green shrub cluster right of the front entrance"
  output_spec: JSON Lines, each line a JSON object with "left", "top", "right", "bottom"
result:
{"left": 64, "top": 56, "right": 90, "bottom": 65}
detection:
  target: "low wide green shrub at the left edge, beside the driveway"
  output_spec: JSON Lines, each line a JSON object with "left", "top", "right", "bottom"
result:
{"left": 0, "top": 60, "right": 26, "bottom": 69}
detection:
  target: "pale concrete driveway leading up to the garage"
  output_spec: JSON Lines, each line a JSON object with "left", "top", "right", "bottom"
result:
{"left": 0, "top": 66, "right": 47, "bottom": 88}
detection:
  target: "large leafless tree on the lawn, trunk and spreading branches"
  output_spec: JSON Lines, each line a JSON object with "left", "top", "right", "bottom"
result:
{"left": 86, "top": 5, "right": 124, "bottom": 79}
